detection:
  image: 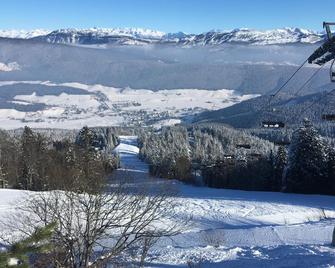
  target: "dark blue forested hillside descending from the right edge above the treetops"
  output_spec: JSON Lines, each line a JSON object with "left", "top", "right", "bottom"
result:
{"left": 194, "top": 90, "right": 335, "bottom": 128}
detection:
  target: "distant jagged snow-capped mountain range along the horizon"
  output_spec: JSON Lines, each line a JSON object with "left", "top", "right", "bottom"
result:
{"left": 0, "top": 28, "right": 325, "bottom": 46}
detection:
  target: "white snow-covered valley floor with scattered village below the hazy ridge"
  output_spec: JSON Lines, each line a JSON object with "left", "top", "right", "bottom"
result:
{"left": 0, "top": 81, "right": 257, "bottom": 129}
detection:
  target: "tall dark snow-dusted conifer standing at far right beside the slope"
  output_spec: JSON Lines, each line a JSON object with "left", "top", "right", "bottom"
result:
{"left": 284, "top": 122, "right": 327, "bottom": 193}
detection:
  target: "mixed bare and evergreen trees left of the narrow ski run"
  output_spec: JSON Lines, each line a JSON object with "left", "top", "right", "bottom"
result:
{"left": 0, "top": 127, "right": 119, "bottom": 191}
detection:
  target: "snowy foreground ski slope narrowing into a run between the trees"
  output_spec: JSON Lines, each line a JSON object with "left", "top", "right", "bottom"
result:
{"left": 0, "top": 137, "right": 335, "bottom": 267}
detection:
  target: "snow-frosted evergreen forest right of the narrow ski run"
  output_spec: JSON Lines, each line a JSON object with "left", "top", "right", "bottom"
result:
{"left": 139, "top": 121, "right": 335, "bottom": 194}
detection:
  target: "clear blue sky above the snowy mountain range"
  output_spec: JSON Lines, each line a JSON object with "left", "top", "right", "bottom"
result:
{"left": 0, "top": 0, "right": 335, "bottom": 33}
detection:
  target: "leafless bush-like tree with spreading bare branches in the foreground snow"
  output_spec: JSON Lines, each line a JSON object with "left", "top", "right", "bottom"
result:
{"left": 2, "top": 181, "right": 185, "bottom": 268}
